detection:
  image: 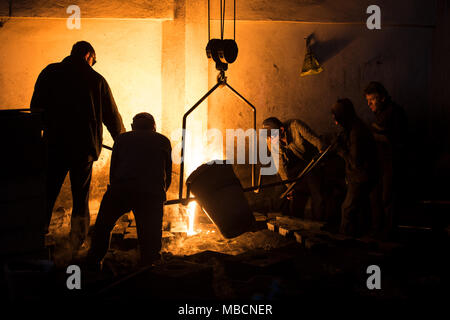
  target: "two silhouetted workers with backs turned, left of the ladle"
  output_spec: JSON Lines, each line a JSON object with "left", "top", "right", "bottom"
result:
{"left": 30, "top": 41, "right": 172, "bottom": 269}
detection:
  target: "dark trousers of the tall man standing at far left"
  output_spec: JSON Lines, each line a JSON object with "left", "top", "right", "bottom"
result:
{"left": 46, "top": 156, "right": 92, "bottom": 246}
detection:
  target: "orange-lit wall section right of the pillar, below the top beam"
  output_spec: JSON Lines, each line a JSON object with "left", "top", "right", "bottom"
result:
{"left": 209, "top": 22, "right": 433, "bottom": 133}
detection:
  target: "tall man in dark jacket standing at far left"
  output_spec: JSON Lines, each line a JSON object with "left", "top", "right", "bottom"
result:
{"left": 31, "top": 41, "right": 125, "bottom": 250}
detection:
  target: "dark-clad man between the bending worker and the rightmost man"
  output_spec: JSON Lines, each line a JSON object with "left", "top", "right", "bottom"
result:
{"left": 331, "top": 99, "right": 379, "bottom": 236}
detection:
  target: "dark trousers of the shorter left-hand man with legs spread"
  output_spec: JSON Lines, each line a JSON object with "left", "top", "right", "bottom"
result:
{"left": 87, "top": 186, "right": 164, "bottom": 264}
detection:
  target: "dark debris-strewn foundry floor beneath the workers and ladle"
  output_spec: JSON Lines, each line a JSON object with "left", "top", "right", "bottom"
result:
{"left": 2, "top": 210, "right": 450, "bottom": 312}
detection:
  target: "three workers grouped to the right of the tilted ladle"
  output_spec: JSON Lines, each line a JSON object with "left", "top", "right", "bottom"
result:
{"left": 263, "top": 82, "right": 407, "bottom": 239}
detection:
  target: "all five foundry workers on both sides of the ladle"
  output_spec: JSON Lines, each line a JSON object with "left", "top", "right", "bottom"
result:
{"left": 31, "top": 41, "right": 406, "bottom": 268}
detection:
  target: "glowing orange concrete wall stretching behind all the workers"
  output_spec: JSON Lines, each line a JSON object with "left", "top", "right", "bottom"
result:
{"left": 0, "top": 0, "right": 448, "bottom": 210}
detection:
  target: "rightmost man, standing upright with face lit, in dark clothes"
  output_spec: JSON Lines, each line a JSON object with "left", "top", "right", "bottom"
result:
{"left": 364, "top": 81, "right": 408, "bottom": 238}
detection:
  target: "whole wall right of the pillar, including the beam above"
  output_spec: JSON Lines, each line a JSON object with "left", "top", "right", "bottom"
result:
{"left": 208, "top": 1, "right": 435, "bottom": 188}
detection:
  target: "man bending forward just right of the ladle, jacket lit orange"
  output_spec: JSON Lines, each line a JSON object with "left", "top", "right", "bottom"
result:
{"left": 263, "top": 117, "right": 325, "bottom": 220}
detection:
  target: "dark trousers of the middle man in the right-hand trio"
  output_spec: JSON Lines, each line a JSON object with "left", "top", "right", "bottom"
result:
{"left": 340, "top": 183, "right": 372, "bottom": 237}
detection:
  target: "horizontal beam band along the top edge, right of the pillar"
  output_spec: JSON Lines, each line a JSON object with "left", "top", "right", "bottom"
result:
{"left": 211, "top": 0, "right": 436, "bottom": 24}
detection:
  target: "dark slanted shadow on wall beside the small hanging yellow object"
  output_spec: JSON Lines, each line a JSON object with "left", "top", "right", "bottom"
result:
{"left": 308, "top": 33, "right": 354, "bottom": 64}
